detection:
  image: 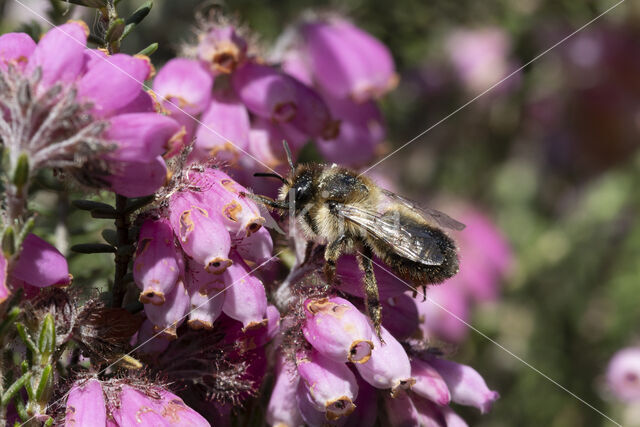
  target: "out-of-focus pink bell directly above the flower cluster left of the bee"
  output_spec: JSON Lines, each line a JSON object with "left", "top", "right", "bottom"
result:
{"left": 193, "top": 94, "right": 250, "bottom": 163}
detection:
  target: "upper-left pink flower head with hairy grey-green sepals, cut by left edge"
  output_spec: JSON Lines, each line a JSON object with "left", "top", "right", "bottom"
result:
{"left": 0, "top": 22, "right": 185, "bottom": 197}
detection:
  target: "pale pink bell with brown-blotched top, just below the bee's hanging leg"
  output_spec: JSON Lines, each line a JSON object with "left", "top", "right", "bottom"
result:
{"left": 302, "top": 297, "right": 373, "bottom": 363}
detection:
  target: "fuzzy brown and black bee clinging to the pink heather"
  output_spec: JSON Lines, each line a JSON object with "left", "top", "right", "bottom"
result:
{"left": 246, "top": 142, "right": 465, "bottom": 336}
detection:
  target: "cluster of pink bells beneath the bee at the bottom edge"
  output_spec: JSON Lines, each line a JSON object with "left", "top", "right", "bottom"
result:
{"left": 267, "top": 297, "right": 498, "bottom": 426}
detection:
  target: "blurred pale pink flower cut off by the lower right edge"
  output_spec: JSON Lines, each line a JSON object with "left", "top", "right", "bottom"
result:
{"left": 606, "top": 347, "right": 640, "bottom": 402}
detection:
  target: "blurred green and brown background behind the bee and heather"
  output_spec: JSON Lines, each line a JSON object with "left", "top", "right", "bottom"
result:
{"left": 0, "top": 0, "right": 640, "bottom": 426}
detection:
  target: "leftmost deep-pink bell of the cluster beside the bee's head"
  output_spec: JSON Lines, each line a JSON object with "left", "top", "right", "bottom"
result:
{"left": 133, "top": 219, "right": 182, "bottom": 305}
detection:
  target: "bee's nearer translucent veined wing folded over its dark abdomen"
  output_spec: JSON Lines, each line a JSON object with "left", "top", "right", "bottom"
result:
{"left": 336, "top": 204, "right": 444, "bottom": 265}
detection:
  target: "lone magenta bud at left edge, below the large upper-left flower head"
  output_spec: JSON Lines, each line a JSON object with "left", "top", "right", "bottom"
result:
{"left": 11, "top": 233, "right": 71, "bottom": 288}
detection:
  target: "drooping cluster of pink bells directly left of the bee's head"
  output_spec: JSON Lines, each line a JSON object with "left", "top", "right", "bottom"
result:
{"left": 133, "top": 167, "right": 273, "bottom": 339}
